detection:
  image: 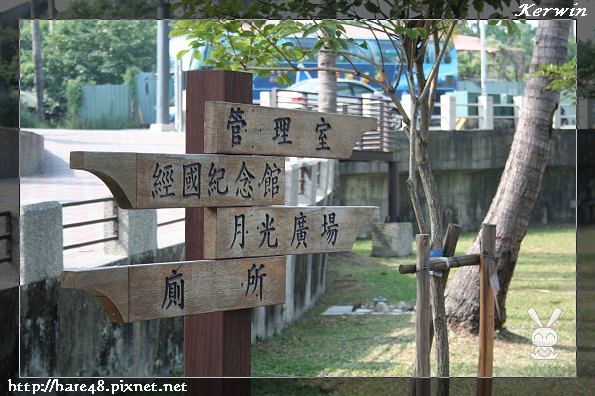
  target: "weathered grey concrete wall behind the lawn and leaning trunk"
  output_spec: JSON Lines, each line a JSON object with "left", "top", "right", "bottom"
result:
{"left": 337, "top": 130, "right": 576, "bottom": 232}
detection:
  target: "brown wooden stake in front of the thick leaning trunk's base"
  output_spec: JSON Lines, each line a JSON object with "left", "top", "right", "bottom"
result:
{"left": 477, "top": 224, "right": 496, "bottom": 396}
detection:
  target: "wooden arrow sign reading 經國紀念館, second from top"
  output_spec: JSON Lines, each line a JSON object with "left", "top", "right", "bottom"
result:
{"left": 70, "top": 151, "right": 285, "bottom": 209}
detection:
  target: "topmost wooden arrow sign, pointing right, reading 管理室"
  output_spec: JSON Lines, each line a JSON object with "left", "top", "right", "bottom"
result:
{"left": 205, "top": 102, "right": 376, "bottom": 159}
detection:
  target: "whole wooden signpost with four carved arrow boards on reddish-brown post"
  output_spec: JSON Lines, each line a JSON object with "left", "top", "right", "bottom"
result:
{"left": 62, "top": 71, "right": 378, "bottom": 378}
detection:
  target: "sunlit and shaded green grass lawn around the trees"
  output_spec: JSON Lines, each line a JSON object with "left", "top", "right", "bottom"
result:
{"left": 252, "top": 225, "right": 576, "bottom": 377}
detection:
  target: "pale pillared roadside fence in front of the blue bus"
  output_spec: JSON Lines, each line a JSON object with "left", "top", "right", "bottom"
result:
{"left": 261, "top": 89, "right": 576, "bottom": 135}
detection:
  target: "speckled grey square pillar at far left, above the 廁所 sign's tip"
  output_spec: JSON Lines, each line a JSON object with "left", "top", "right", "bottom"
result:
{"left": 19, "top": 201, "right": 64, "bottom": 285}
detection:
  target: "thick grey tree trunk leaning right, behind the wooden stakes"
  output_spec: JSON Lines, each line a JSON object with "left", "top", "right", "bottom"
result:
{"left": 446, "top": 20, "right": 571, "bottom": 334}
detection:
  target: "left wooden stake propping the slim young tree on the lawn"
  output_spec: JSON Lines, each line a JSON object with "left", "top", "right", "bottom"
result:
{"left": 415, "top": 234, "right": 432, "bottom": 395}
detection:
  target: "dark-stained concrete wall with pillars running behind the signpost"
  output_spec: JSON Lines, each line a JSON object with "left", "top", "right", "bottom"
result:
{"left": 18, "top": 160, "right": 338, "bottom": 377}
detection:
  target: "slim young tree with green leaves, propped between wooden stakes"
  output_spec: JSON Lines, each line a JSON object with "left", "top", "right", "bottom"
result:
{"left": 172, "top": 0, "right": 516, "bottom": 391}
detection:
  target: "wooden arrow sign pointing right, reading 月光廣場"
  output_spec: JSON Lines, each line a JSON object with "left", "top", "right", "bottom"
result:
{"left": 204, "top": 206, "right": 378, "bottom": 259}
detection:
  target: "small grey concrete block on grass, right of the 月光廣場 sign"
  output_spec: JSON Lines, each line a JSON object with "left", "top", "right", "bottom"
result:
{"left": 372, "top": 223, "right": 413, "bottom": 257}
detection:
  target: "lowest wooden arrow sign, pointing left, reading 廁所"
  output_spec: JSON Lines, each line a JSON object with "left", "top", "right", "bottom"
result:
{"left": 61, "top": 257, "right": 285, "bottom": 323}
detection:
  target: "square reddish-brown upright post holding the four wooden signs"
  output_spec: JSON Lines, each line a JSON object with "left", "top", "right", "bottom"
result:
{"left": 184, "top": 70, "right": 252, "bottom": 378}
